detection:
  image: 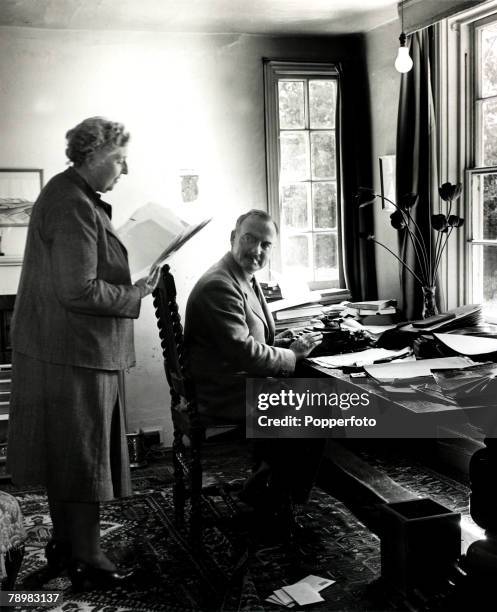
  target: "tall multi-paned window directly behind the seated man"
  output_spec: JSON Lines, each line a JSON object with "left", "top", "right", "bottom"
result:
{"left": 265, "top": 61, "right": 341, "bottom": 288}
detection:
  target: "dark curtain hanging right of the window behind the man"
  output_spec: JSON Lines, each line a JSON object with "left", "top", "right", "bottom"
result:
{"left": 338, "top": 51, "right": 377, "bottom": 300}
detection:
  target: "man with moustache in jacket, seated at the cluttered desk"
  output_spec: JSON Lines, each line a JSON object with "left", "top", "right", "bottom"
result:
{"left": 185, "top": 210, "right": 322, "bottom": 532}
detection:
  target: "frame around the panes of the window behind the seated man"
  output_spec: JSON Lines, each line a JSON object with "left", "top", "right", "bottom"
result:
{"left": 263, "top": 59, "right": 344, "bottom": 289}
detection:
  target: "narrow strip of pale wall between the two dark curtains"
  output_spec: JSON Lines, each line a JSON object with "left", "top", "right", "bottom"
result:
{"left": 365, "top": 21, "right": 401, "bottom": 303}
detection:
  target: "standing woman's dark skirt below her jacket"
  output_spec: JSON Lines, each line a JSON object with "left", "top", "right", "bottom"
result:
{"left": 7, "top": 353, "right": 131, "bottom": 502}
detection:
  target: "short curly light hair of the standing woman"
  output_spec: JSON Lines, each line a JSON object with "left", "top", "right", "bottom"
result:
{"left": 66, "top": 117, "right": 129, "bottom": 166}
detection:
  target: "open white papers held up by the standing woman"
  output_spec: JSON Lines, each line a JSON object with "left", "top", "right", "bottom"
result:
{"left": 117, "top": 203, "right": 211, "bottom": 275}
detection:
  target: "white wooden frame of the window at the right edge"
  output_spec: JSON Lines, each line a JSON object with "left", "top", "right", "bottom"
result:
{"left": 442, "top": 0, "right": 497, "bottom": 308}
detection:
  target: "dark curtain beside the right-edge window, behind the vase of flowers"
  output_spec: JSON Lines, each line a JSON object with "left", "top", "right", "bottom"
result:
{"left": 396, "top": 26, "right": 440, "bottom": 319}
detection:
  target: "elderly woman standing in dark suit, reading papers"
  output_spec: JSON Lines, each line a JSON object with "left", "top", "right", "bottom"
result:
{"left": 8, "top": 117, "right": 156, "bottom": 588}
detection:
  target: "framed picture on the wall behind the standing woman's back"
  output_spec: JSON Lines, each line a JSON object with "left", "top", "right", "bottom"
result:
{"left": 0, "top": 168, "right": 43, "bottom": 264}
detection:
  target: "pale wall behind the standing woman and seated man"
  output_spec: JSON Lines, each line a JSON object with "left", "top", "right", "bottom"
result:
{"left": 0, "top": 27, "right": 356, "bottom": 444}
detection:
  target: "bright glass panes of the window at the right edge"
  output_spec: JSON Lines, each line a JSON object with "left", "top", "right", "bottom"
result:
{"left": 467, "top": 15, "right": 497, "bottom": 307}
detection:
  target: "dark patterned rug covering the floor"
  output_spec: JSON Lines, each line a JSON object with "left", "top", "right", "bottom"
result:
{"left": 11, "top": 447, "right": 472, "bottom": 612}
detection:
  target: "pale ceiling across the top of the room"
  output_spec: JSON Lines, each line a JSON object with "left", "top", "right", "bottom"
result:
{"left": 0, "top": 0, "right": 397, "bottom": 35}
